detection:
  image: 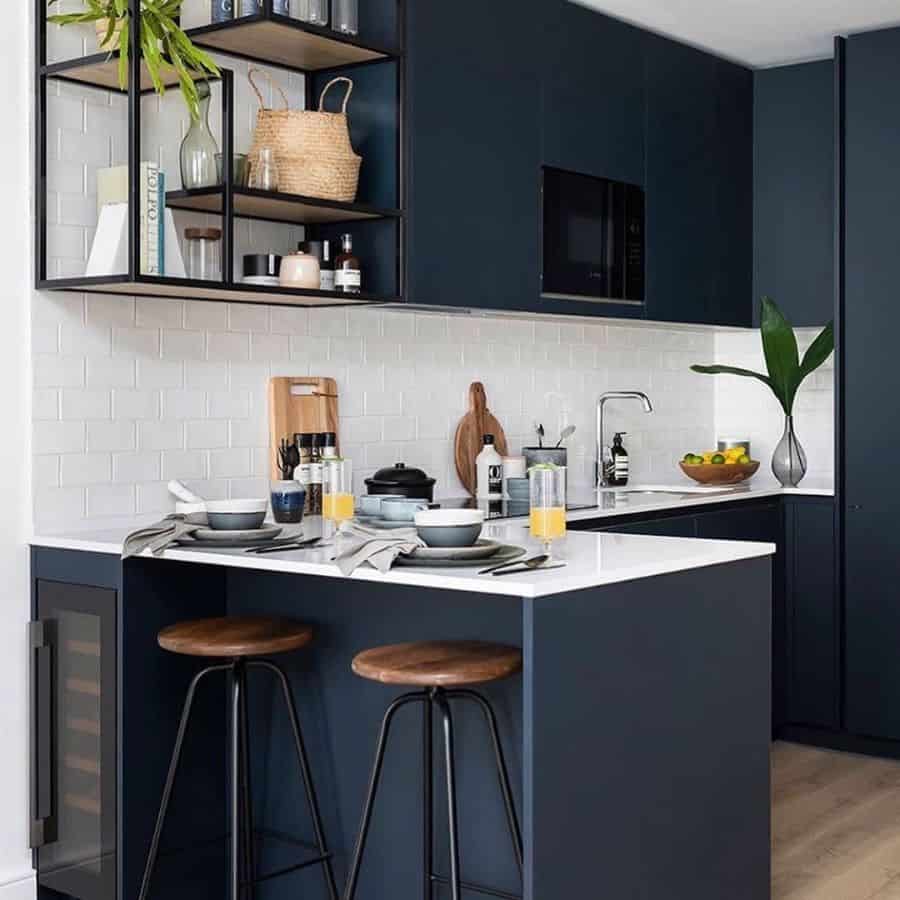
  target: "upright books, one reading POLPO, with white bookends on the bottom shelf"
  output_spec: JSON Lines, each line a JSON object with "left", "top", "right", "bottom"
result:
{"left": 85, "top": 162, "right": 185, "bottom": 278}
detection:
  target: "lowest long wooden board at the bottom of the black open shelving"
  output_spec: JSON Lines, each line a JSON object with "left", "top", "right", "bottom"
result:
{"left": 37, "top": 276, "right": 402, "bottom": 307}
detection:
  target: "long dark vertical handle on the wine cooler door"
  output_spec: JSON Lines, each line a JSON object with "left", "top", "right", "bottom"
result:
{"left": 29, "top": 621, "right": 57, "bottom": 849}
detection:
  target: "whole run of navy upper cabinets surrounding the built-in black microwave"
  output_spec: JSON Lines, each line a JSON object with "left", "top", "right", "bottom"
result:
{"left": 406, "top": 0, "right": 753, "bottom": 326}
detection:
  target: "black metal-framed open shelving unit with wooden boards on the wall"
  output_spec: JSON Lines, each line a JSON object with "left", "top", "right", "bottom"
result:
{"left": 35, "top": 0, "right": 405, "bottom": 306}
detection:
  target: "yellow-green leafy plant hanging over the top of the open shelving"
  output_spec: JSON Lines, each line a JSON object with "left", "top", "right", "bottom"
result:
{"left": 47, "top": 0, "right": 219, "bottom": 119}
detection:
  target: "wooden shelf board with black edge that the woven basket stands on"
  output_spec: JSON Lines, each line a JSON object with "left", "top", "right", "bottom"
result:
{"left": 166, "top": 188, "right": 400, "bottom": 225}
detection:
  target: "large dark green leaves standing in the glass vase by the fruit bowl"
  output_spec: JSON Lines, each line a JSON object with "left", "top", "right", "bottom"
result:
{"left": 691, "top": 297, "right": 834, "bottom": 416}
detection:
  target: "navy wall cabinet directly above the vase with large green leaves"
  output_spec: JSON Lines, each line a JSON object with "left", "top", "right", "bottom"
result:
{"left": 753, "top": 60, "right": 834, "bottom": 326}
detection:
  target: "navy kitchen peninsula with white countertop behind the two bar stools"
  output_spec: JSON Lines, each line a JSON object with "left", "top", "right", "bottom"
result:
{"left": 33, "top": 522, "right": 775, "bottom": 900}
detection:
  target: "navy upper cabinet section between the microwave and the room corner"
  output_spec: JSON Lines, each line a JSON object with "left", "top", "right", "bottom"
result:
{"left": 646, "top": 36, "right": 753, "bottom": 325}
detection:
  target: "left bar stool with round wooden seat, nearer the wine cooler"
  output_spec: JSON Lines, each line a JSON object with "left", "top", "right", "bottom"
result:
{"left": 139, "top": 616, "right": 338, "bottom": 900}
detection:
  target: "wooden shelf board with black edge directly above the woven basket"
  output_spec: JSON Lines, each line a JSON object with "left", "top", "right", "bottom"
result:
{"left": 188, "top": 16, "right": 392, "bottom": 71}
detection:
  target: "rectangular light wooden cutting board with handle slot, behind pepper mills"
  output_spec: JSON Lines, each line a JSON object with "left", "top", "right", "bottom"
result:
{"left": 269, "top": 375, "right": 341, "bottom": 480}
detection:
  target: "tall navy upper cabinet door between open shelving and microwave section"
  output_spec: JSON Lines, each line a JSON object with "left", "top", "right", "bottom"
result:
{"left": 406, "top": 0, "right": 541, "bottom": 309}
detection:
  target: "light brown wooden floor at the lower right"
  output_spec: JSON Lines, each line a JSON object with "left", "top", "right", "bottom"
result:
{"left": 772, "top": 743, "right": 900, "bottom": 900}
